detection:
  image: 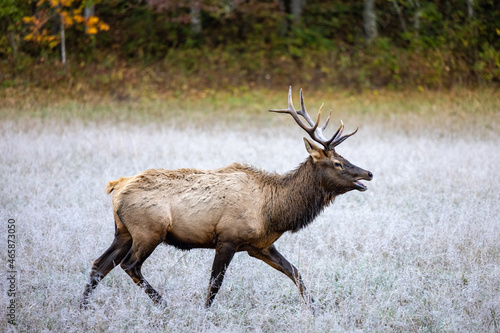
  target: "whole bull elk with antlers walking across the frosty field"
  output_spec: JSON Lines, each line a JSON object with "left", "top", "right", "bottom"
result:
{"left": 81, "top": 87, "right": 373, "bottom": 308}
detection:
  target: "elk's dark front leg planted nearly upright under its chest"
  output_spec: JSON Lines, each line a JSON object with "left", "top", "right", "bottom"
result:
{"left": 205, "top": 244, "right": 235, "bottom": 308}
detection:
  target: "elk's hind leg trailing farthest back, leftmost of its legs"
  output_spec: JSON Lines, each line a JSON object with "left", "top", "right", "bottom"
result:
{"left": 80, "top": 228, "right": 132, "bottom": 308}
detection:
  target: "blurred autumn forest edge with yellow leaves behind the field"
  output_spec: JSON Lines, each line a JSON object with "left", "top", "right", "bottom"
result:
{"left": 0, "top": 0, "right": 500, "bottom": 94}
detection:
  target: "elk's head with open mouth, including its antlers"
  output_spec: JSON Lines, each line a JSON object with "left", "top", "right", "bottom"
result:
{"left": 269, "top": 86, "right": 373, "bottom": 194}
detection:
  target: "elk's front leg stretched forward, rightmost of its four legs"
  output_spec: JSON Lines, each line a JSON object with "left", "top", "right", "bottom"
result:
{"left": 248, "top": 245, "right": 314, "bottom": 311}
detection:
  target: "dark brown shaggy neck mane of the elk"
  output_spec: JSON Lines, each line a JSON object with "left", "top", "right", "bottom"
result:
{"left": 261, "top": 157, "right": 335, "bottom": 232}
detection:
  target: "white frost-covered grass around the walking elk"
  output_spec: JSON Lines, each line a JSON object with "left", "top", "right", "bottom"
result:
{"left": 0, "top": 107, "right": 500, "bottom": 332}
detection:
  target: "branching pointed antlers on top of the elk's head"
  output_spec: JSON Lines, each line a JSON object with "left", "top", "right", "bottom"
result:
{"left": 269, "top": 86, "right": 358, "bottom": 150}
